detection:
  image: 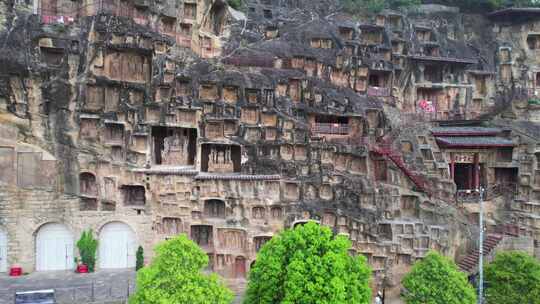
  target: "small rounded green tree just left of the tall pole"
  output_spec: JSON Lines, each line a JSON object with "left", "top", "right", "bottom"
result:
{"left": 401, "top": 251, "right": 476, "bottom": 304}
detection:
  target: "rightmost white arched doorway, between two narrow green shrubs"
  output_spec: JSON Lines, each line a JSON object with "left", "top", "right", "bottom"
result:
{"left": 99, "top": 222, "right": 136, "bottom": 269}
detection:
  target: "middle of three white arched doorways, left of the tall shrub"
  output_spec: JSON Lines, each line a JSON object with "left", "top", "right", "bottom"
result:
{"left": 36, "top": 223, "right": 75, "bottom": 271}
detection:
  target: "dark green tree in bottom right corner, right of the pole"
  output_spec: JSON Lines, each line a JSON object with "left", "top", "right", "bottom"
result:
{"left": 485, "top": 252, "right": 540, "bottom": 304}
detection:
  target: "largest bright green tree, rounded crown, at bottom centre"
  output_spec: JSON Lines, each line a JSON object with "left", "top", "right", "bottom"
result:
{"left": 244, "top": 222, "right": 371, "bottom": 304}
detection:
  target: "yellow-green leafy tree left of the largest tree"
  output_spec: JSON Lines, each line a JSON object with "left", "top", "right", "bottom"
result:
{"left": 129, "top": 234, "right": 233, "bottom": 304}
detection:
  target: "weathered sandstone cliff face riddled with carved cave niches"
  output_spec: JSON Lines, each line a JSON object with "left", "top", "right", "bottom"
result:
{"left": 0, "top": 0, "right": 540, "bottom": 295}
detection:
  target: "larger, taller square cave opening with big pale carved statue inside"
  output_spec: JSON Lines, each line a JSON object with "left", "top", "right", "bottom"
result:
{"left": 152, "top": 126, "right": 197, "bottom": 166}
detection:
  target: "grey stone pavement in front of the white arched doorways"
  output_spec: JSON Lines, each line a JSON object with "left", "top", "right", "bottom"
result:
{"left": 0, "top": 269, "right": 135, "bottom": 304}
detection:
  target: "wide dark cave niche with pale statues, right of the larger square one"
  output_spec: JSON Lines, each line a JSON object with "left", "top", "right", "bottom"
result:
{"left": 201, "top": 144, "right": 241, "bottom": 173}
